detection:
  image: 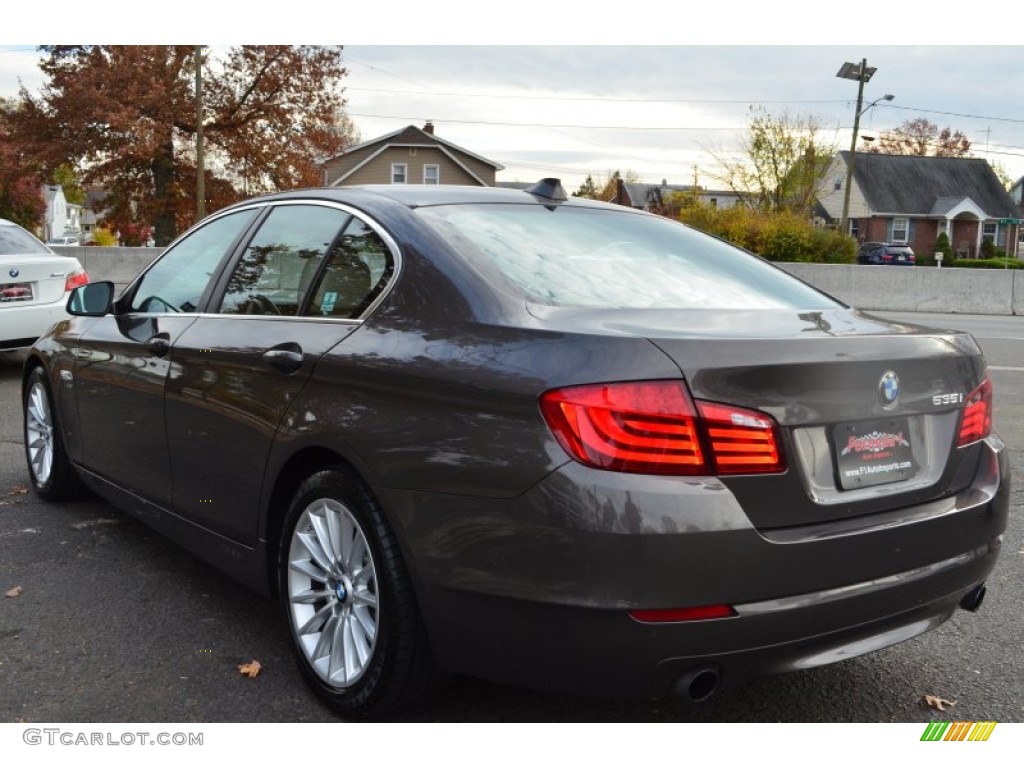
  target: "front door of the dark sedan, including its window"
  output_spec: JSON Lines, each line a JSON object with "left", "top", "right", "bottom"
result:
{"left": 71, "top": 208, "right": 258, "bottom": 506}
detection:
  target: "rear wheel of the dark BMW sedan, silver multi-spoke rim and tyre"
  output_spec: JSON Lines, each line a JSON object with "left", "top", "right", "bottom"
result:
{"left": 279, "top": 468, "right": 441, "bottom": 718}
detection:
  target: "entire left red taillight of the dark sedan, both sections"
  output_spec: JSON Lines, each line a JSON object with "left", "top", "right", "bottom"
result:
{"left": 541, "top": 381, "right": 785, "bottom": 475}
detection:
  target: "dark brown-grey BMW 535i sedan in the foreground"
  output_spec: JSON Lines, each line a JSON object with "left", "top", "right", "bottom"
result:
{"left": 24, "top": 179, "right": 1009, "bottom": 717}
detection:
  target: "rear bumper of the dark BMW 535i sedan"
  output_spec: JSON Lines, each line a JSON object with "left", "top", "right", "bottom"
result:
{"left": 379, "top": 437, "right": 1009, "bottom": 695}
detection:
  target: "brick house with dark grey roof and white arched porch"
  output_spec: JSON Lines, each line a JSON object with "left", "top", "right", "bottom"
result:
{"left": 818, "top": 152, "right": 1020, "bottom": 258}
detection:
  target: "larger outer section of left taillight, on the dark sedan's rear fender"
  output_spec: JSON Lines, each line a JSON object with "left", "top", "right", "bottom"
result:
{"left": 541, "top": 381, "right": 706, "bottom": 474}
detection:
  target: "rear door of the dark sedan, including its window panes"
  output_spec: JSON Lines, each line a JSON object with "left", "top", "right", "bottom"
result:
{"left": 166, "top": 203, "right": 393, "bottom": 544}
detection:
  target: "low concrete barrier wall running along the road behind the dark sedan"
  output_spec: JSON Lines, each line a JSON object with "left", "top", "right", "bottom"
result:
{"left": 53, "top": 246, "right": 1024, "bottom": 314}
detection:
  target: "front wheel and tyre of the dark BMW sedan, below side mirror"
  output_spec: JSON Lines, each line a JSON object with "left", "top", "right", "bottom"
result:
{"left": 22, "top": 367, "right": 86, "bottom": 502}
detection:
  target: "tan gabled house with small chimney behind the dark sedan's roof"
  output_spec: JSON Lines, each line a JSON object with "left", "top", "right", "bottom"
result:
{"left": 321, "top": 123, "right": 505, "bottom": 186}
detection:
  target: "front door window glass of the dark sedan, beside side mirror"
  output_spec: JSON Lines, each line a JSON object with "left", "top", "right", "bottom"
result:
{"left": 131, "top": 208, "right": 257, "bottom": 312}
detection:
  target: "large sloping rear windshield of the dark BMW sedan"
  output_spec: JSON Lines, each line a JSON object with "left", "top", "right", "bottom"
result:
{"left": 417, "top": 205, "right": 840, "bottom": 309}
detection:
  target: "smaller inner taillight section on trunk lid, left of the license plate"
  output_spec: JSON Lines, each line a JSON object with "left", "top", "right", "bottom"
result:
{"left": 697, "top": 400, "right": 785, "bottom": 474}
